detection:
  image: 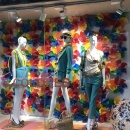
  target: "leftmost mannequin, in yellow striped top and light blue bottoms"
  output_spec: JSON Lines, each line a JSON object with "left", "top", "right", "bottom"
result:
{"left": 10, "top": 37, "right": 28, "bottom": 127}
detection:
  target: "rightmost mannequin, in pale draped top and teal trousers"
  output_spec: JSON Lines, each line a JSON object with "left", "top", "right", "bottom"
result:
{"left": 81, "top": 34, "right": 105, "bottom": 130}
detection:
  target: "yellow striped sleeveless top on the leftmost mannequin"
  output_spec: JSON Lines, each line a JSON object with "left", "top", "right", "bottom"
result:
{"left": 12, "top": 49, "right": 27, "bottom": 67}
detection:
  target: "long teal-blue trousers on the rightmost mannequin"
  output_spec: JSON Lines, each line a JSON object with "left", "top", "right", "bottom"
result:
{"left": 84, "top": 74, "right": 102, "bottom": 119}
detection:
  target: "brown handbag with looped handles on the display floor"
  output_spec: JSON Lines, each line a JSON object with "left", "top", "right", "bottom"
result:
{"left": 56, "top": 111, "right": 73, "bottom": 130}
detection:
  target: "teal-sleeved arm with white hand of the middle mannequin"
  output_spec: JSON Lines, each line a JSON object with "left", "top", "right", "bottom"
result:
{"left": 66, "top": 46, "right": 73, "bottom": 78}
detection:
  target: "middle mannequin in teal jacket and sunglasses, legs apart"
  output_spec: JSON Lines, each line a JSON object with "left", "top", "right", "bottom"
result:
{"left": 48, "top": 33, "right": 73, "bottom": 128}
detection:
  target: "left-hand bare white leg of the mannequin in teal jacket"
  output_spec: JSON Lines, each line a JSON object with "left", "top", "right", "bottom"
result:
{"left": 48, "top": 87, "right": 59, "bottom": 119}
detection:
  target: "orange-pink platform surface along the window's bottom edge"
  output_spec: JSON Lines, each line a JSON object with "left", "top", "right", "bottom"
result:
{"left": 0, "top": 120, "right": 112, "bottom": 130}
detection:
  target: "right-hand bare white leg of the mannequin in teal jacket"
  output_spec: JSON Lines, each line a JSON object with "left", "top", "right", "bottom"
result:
{"left": 61, "top": 87, "right": 71, "bottom": 115}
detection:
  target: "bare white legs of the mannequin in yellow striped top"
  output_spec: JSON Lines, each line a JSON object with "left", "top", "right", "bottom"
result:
{"left": 13, "top": 87, "right": 24, "bottom": 124}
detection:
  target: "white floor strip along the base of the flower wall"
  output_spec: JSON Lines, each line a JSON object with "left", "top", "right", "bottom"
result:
{"left": 0, "top": 114, "right": 111, "bottom": 127}
